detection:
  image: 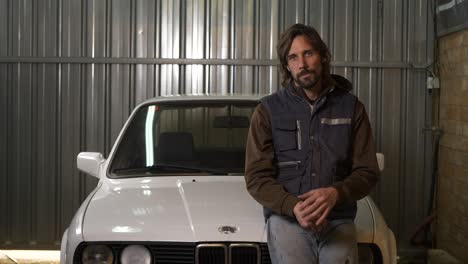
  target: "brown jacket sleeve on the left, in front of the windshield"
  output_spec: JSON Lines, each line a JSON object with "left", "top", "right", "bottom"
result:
{"left": 245, "top": 104, "right": 299, "bottom": 217}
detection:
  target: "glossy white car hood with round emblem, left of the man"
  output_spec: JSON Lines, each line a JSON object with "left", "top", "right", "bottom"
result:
{"left": 83, "top": 176, "right": 265, "bottom": 242}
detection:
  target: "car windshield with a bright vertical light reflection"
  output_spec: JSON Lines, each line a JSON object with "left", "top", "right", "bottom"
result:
{"left": 109, "top": 101, "right": 257, "bottom": 177}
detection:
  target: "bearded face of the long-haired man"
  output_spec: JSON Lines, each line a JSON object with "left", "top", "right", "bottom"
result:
{"left": 286, "top": 35, "right": 322, "bottom": 89}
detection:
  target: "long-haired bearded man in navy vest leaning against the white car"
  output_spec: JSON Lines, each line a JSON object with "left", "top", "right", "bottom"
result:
{"left": 245, "top": 24, "right": 379, "bottom": 264}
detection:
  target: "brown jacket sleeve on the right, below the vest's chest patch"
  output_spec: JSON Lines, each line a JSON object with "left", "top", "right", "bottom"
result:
{"left": 333, "top": 101, "right": 380, "bottom": 203}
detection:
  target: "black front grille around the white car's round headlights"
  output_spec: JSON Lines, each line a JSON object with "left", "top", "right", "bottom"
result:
{"left": 73, "top": 242, "right": 271, "bottom": 264}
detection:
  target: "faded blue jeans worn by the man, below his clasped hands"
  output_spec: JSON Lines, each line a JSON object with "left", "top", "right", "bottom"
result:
{"left": 267, "top": 214, "right": 358, "bottom": 264}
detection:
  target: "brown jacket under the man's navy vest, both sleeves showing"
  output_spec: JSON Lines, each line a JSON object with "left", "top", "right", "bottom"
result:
{"left": 245, "top": 83, "right": 379, "bottom": 217}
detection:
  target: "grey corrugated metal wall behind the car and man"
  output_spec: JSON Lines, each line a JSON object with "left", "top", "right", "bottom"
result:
{"left": 0, "top": 0, "right": 434, "bottom": 250}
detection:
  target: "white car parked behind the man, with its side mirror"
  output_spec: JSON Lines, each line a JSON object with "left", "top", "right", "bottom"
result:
{"left": 60, "top": 95, "right": 397, "bottom": 264}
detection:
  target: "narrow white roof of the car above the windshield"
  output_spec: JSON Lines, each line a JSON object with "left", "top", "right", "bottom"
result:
{"left": 142, "top": 94, "right": 268, "bottom": 104}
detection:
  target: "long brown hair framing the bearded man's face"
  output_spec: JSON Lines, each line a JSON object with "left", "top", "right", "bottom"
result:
{"left": 276, "top": 24, "right": 333, "bottom": 87}
